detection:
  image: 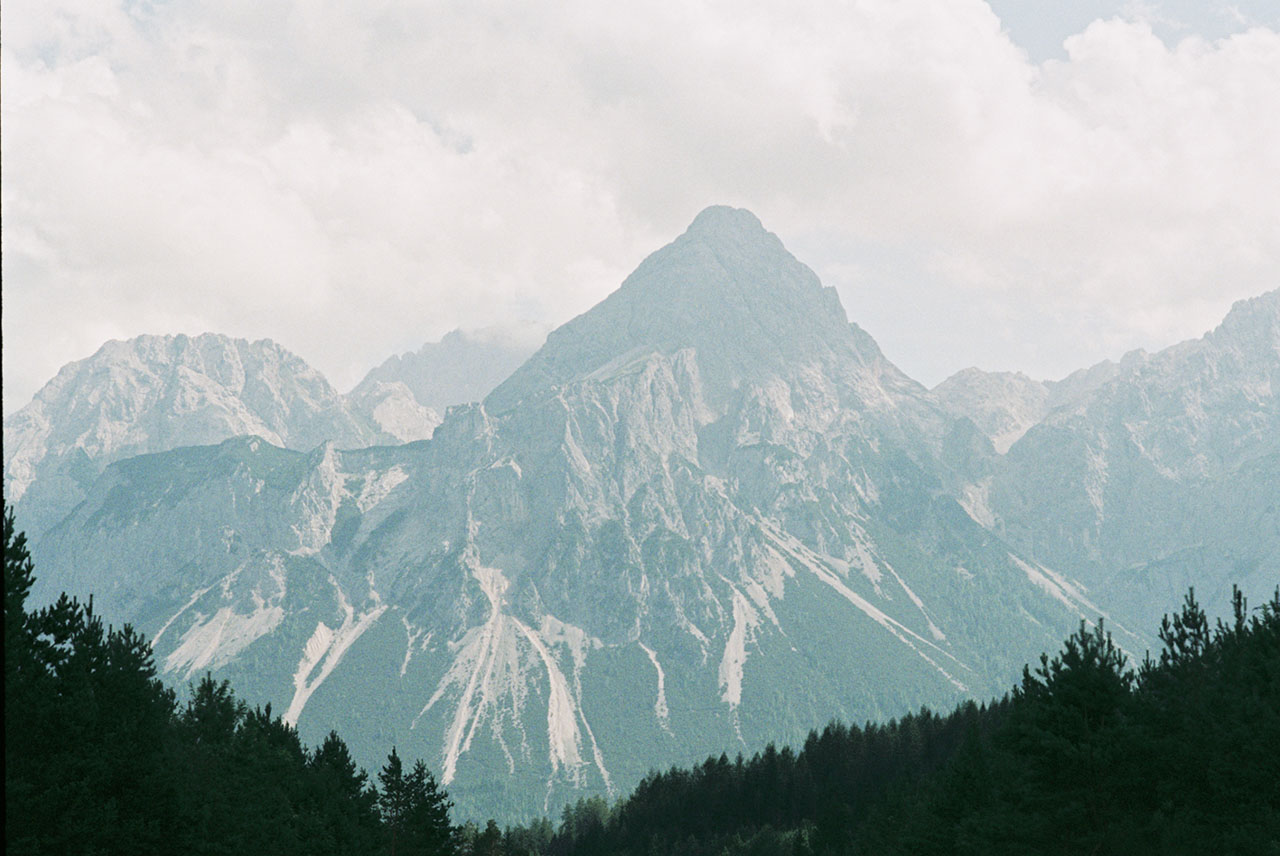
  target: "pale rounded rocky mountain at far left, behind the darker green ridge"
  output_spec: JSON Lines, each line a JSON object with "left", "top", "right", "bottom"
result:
{"left": 4, "top": 333, "right": 389, "bottom": 534}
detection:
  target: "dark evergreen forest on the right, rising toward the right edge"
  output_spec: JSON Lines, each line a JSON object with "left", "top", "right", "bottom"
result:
{"left": 506, "top": 589, "right": 1280, "bottom": 856}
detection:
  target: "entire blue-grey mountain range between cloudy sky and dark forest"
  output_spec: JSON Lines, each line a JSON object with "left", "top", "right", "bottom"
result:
{"left": 4, "top": 207, "right": 1280, "bottom": 820}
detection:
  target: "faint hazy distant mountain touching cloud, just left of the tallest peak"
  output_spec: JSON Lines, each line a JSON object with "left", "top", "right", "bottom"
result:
{"left": 352, "top": 322, "right": 548, "bottom": 413}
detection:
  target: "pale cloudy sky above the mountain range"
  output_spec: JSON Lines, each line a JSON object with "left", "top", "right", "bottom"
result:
{"left": 0, "top": 0, "right": 1280, "bottom": 413}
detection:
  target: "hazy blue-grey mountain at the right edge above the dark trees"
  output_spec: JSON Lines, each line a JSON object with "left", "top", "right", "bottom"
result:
{"left": 970, "top": 290, "right": 1280, "bottom": 626}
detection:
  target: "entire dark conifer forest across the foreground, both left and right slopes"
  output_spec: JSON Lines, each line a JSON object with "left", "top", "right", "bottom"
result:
{"left": 4, "top": 512, "right": 1280, "bottom": 856}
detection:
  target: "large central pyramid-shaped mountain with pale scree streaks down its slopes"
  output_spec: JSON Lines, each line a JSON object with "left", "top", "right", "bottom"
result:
{"left": 17, "top": 207, "right": 1121, "bottom": 819}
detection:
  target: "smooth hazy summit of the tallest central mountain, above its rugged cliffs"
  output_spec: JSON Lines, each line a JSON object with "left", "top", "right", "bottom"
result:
{"left": 485, "top": 206, "right": 890, "bottom": 412}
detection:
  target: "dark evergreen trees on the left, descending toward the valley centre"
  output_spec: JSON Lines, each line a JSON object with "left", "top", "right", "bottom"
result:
{"left": 4, "top": 509, "right": 454, "bottom": 856}
